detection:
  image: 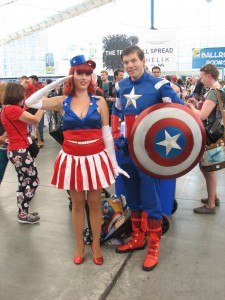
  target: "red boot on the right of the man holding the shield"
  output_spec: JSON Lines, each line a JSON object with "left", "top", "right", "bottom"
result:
{"left": 143, "top": 219, "right": 162, "bottom": 271}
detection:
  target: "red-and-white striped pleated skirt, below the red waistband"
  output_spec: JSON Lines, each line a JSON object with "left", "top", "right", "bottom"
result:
{"left": 51, "top": 144, "right": 115, "bottom": 191}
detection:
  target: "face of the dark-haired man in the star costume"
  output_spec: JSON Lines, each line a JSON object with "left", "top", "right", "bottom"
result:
{"left": 123, "top": 52, "right": 145, "bottom": 81}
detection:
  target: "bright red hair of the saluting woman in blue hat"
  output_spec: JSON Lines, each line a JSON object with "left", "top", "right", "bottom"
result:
{"left": 63, "top": 60, "right": 96, "bottom": 96}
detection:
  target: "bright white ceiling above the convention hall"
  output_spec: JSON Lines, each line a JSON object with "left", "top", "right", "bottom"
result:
{"left": 0, "top": 0, "right": 225, "bottom": 46}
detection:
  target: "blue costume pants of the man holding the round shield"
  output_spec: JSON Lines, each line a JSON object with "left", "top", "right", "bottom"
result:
{"left": 121, "top": 155, "right": 162, "bottom": 220}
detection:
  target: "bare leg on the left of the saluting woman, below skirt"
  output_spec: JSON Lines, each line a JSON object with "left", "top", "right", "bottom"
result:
{"left": 70, "top": 190, "right": 85, "bottom": 257}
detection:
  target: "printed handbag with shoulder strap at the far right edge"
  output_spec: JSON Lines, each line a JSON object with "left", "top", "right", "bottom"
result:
{"left": 200, "top": 90, "right": 225, "bottom": 172}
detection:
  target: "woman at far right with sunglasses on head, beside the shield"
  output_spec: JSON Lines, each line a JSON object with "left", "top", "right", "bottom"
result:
{"left": 186, "top": 64, "right": 223, "bottom": 214}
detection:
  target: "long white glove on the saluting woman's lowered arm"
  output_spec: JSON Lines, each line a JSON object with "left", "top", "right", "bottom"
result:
{"left": 102, "top": 125, "right": 130, "bottom": 178}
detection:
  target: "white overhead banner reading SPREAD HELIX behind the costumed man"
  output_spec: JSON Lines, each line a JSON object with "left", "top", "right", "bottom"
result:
{"left": 103, "top": 31, "right": 176, "bottom": 72}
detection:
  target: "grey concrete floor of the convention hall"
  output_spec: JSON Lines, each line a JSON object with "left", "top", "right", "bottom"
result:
{"left": 0, "top": 133, "right": 225, "bottom": 300}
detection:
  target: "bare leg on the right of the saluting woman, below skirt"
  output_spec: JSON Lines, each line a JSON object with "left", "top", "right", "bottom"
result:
{"left": 87, "top": 190, "right": 102, "bottom": 258}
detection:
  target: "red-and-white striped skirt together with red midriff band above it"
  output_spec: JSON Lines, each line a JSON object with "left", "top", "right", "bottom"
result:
{"left": 51, "top": 129, "right": 115, "bottom": 191}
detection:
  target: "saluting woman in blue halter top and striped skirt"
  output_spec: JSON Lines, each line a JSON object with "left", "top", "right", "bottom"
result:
{"left": 26, "top": 55, "right": 129, "bottom": 265}
